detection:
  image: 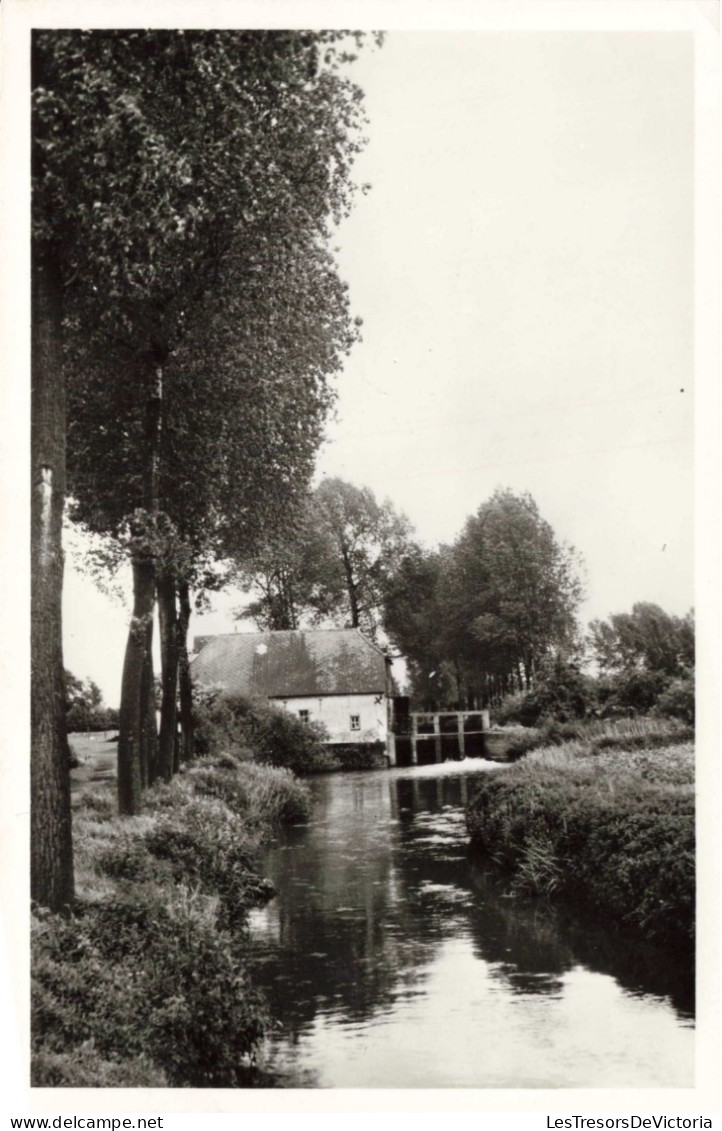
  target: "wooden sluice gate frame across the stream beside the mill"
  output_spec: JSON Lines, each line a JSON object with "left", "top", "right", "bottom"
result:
{"left": 389, "top": 699, "right": 489, "bottom": 766}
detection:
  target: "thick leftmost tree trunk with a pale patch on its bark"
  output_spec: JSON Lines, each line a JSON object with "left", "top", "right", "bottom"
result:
{"left": 31, "top": 247, "right": 74, "bottom": 910}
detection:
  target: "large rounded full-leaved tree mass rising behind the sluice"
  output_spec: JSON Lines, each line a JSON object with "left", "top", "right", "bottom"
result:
{"left": 385, "top": 490, "right": 582, "bottom": 708}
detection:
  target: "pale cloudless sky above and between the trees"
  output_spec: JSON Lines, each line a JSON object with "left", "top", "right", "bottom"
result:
{"left": 63, "top": 31, "right": 695, "bottom": 706}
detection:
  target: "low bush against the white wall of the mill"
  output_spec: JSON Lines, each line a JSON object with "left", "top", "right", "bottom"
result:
{"left": 195, "top": 691, "right": 332, "bottom": 774}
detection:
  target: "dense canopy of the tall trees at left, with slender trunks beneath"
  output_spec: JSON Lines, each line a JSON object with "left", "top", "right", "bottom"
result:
{"left": 33, "top": 31, "right": 375, "bottom": 832}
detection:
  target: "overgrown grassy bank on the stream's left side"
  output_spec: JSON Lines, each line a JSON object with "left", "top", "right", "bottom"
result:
{"left": 32, "top": 756, "right": 308, "bottom": 1087}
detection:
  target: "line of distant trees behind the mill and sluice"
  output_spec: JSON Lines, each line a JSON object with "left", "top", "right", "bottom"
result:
{"left": 234, "top": 478, "right": 695, "bottom": 725}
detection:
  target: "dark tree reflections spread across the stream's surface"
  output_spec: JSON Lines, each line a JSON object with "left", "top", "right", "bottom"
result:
{"left": 255, "top": 774, "right": 690, "bottom": 1082}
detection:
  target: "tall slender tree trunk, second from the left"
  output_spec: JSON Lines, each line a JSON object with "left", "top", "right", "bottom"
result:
{"left": 118, "top": 363, "right": 163, "bottom": 814}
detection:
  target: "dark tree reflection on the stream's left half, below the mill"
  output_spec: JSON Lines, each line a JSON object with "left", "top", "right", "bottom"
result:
{"left": 248, "top": 778, "right": 441, "bottom": 1042}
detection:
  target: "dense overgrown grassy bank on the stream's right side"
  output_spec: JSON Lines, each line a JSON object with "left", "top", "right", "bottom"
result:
{"left": 466, "top": 720, "right": 695, "bottom": 950}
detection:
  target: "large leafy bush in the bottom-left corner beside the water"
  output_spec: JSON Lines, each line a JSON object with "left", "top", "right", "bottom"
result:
{"left": 32, "top": 892, "right": 267, "bottom": 1088}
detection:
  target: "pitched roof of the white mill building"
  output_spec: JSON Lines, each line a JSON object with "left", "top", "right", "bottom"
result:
{"left": 190, "top": 629, "right": 386, "bottom": 699}
